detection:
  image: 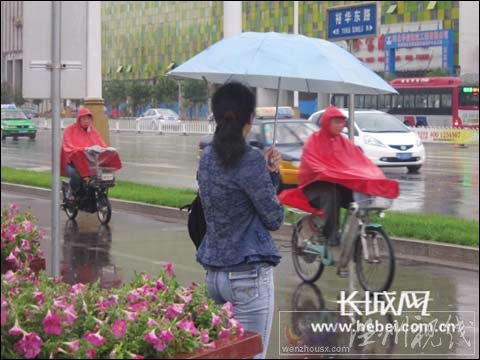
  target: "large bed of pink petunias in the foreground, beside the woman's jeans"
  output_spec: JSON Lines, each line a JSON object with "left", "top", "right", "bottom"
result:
{"left": 1, "top": 264, "right": 251, "bottom": 359}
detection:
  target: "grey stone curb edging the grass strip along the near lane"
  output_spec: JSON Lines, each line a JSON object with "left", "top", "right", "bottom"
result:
{"left": 1, "top": 182, "right": 479, "bottom": 272}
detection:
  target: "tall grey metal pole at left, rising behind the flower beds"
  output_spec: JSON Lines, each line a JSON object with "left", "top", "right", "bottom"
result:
{"left": 49, "top": 1, "right": 62, "bottom": 277}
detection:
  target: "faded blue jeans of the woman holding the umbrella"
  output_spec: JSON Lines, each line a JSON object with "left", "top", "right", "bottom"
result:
{"left": 206, "top": 265, "right": 274, "bottom": 359}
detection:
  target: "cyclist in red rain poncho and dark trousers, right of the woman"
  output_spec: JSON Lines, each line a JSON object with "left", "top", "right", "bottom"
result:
{"left": 279, "top": 106, "right": 399, "bottom": 246}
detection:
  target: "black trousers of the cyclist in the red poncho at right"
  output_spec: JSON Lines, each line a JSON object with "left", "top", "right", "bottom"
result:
{"left": 303, "top": 181, "right": 353, "bottom": 245}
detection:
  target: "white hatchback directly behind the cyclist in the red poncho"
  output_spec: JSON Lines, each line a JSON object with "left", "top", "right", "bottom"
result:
{"left": 309, "top": 109, "right": 425, "bottom": 173}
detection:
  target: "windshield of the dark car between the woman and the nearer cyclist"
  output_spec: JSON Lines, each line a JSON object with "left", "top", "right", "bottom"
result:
{"left": 265, "top": 122, "right": 318, "bottom": 146}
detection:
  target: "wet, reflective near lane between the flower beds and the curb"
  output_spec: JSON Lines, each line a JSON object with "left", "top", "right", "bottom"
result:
{"left": 1, "top": 192, "right": 479, "bottom": 358}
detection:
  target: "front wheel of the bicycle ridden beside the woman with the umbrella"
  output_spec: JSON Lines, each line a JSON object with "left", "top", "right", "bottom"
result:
{"left": 354, "top": 228, "right": 395, "bottom": 292}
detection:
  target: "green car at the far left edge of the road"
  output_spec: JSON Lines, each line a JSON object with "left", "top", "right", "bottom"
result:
{"left": 2, "top": 104, "right": 37, "bottom": 140}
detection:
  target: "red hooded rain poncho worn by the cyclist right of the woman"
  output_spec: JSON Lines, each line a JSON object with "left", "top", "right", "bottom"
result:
{"left": 279, "top": 106, "right": 399, "bottom": 212}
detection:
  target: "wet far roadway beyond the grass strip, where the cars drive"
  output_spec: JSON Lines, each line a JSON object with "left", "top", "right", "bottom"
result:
{"left": 1, "top": 131, "right": 479, "bottom": 220}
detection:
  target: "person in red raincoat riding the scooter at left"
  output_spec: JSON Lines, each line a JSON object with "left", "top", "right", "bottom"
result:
{"left": 61, "top": 107, "right": 121, "bottom": 194}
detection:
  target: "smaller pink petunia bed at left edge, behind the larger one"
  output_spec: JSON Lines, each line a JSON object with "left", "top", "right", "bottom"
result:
{"left": 1, "top": 204, "right": 45, "bottom": 274}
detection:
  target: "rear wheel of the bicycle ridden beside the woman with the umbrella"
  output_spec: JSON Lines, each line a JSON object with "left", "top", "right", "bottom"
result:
{"left": 292, "top": 217, "right": 324, "bottom": 283}
